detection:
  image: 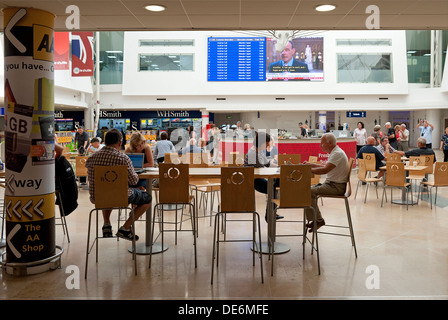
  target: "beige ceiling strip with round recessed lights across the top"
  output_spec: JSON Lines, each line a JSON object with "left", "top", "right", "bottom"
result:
{"left": 0, "top": 0, "right": 448, "bottom": 31}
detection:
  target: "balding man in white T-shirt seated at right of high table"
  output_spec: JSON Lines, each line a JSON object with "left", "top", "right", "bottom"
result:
{"left": 304, "top": 133, "right": 351, "bottom": 232}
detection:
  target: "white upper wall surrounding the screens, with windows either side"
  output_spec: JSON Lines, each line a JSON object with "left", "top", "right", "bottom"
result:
{"left": 123, "top": 31, "right": 408, "bottom": 97}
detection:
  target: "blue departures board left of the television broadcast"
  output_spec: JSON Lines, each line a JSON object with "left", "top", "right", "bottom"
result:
{"left": 207, "top": 37, "right": 266, "bottom": 81}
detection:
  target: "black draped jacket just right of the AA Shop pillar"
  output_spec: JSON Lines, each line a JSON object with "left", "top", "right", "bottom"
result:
{"left": 55, "top": 156, "right": 78, "bottom": 216}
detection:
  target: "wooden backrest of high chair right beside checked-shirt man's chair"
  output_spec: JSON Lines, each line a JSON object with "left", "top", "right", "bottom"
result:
{"left": 159, "top": 163, "right": 190, "bottom": 204}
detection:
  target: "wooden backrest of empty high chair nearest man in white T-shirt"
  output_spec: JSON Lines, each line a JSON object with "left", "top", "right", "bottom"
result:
{"left": 280, "top": 164, "right": 311, "bottom": 208}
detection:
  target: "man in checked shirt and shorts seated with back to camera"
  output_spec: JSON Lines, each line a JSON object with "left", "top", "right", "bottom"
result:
{"left": 86, "top": 129, "right": 152, "bottom": 240}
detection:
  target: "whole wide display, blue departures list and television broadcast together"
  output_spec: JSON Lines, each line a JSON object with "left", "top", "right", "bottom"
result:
{"left": 207, "top": 37, "right": 324, "bottom": 81}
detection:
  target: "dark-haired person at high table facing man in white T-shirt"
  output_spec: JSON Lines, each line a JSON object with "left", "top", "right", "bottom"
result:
{"left": 244, "top": 131, "right": 283, "bottom": 221}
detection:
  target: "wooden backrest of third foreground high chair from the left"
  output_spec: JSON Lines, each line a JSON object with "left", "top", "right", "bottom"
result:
{"left": 221, "top": 167, "right": 255, "bottom": 212}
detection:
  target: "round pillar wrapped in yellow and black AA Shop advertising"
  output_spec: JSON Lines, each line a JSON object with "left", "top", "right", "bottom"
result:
{"left": 3, "top": 8, "right": 56, "bottom": 263}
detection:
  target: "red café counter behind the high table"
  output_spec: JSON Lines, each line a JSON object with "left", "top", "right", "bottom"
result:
{"left": 219, "top": 138, "right": 356, "bottom": 162}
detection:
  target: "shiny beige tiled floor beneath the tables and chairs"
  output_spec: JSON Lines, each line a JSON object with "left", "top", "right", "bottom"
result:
{"left": 0, "top": 152, "right": 448, "bottom": 299}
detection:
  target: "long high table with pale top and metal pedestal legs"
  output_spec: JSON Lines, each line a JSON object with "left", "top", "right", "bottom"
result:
{"left": 133, "top": 166, "right": 290, "bottom": 255}
